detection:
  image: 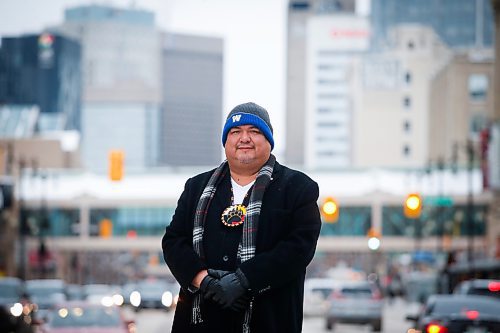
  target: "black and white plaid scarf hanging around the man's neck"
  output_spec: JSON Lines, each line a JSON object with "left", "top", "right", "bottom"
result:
{"left": 191, "top": 155, "right": 276, "bottom": 333}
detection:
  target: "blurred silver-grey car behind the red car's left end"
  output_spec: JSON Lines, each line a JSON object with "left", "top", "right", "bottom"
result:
{"left": 26, "top": 279, "right": 66, "bottom": 318}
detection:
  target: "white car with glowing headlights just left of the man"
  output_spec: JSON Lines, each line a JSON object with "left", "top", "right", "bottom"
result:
{"left": 130, "top": 280, "right": 180, "bottom": 311}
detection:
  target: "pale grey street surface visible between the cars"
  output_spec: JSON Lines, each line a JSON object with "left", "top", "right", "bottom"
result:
{"left": 127, "top": 299, "right": 417, "bottom": 333}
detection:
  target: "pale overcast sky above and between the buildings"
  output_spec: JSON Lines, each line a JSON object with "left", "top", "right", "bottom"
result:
{"left": 0, "top": 0, "right": 287, "bottom": 155}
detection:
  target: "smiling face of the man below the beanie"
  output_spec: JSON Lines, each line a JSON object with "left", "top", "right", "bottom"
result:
{"left": 224, "top": 125, "right": 271, "bottom": 169}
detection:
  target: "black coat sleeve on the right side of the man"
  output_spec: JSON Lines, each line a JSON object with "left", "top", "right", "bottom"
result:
{"left": 240, "top": 179, "right": 321, "bottom": 293}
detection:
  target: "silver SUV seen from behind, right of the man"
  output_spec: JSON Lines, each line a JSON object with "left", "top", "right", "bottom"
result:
{"left": 326, "top": 281, "right": 383, "bottom": 332}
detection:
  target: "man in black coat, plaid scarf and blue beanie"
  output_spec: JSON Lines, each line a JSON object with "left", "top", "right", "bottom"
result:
{"left": 162, "top": 103, "right": 321, "bottom": 333}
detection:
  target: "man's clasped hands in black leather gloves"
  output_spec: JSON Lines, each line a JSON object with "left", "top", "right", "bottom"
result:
{"left": 200, "top": 269, "right": 250, "bottom": 311}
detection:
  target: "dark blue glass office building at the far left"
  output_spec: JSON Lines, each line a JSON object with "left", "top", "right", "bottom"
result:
{"left": 0, "top": 33, "right": 81, "bottom": 132}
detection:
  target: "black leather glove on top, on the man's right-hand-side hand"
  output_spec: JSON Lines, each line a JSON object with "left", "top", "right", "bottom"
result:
{"left": 205, "top": 269, "right": 249, "bottom": 311}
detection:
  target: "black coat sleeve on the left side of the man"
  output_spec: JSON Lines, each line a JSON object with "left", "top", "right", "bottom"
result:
{"left": 162, "top": 179, "right": 206, "bottom": 288}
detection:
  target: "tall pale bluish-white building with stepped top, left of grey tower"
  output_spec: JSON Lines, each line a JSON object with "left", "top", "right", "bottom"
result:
{"left": 54, "top": 5, "right": 161, "bottom": 171}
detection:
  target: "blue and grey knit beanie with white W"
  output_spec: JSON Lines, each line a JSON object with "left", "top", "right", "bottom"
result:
{"left": 222, "top": 102, "right": 274, "bottom": 150}
